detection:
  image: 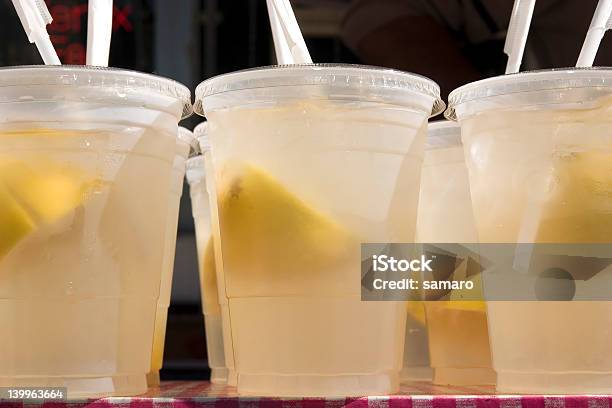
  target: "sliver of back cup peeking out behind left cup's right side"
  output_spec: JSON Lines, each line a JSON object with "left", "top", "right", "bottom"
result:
{"left": 147, "top": 127, "right": 199, "bottom": 387}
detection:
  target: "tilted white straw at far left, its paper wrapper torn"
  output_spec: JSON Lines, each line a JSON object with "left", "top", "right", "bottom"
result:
{"left": 13, "top": 0, "right": 62, "bottom": 65}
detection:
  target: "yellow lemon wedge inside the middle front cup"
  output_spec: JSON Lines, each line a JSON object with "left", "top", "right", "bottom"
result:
{"left": 218, "top": 164, "right": 359, "bottom": 291}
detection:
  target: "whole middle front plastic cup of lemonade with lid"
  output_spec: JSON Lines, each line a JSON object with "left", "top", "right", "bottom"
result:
{"left": 196, "top": 65, "right": 443, "bottom": 396}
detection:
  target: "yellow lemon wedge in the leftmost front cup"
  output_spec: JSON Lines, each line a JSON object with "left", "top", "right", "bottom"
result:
{"left": 0, "top": 158, "right": 92, "bottom": 259}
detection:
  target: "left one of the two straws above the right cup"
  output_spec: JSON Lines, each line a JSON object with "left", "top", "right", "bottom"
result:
{"left": 504, "top": 0, "right": 535, "bottom": 74}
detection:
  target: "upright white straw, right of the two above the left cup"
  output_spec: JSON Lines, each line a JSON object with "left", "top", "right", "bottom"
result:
{"left": 86, "top": 0, "right": 113, "bottom": 67}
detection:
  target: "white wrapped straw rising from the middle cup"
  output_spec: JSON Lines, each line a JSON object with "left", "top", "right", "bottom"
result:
{"left": 267, "top": 0, "right": 312, "bottom": 64}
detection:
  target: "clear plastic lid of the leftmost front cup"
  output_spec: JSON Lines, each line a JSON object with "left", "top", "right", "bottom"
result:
{"left": 0, "top": 65, "right": 193, "bottom": 119}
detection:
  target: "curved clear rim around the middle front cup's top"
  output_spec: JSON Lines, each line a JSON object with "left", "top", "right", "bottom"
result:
{"left": 194, "top": 63, "right": 446, "bottom": 116}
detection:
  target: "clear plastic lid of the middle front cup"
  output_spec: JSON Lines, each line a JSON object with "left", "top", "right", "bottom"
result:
{"left": 194, "top": 64, "right": 445, "bottom": 116}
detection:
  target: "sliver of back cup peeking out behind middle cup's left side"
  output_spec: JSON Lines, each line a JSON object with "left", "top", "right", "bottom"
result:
{"left": 187, "top": 123, "right": 231, "bottom": 384}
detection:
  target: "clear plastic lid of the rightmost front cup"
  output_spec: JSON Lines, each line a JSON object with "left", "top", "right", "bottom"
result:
{"left": 444, "top": 67, "right": 612, "bottom": 120}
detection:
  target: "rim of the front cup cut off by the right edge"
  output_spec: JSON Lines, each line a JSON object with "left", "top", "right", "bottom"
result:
{"left": 444, "top": 67, "right": 612, "bottom": 120}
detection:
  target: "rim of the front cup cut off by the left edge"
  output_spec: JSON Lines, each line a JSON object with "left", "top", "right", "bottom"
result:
{"left": 0, "top": 65, "right": 193, "bottom": 119}
